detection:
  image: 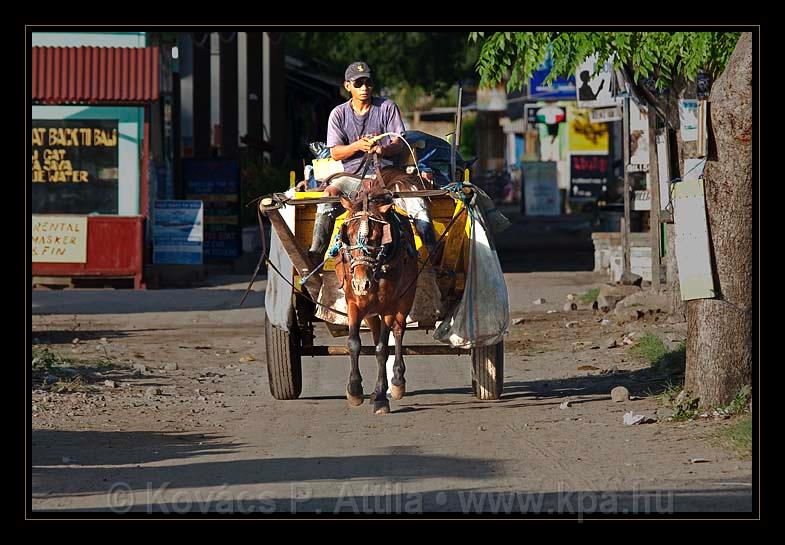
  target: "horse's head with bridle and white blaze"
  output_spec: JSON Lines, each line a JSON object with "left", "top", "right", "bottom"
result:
{"left": 341, "top": 189, "right": 392, "bottom": 297}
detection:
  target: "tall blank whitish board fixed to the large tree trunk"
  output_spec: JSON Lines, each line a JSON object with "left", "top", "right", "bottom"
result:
{"left": 673, "top": 180, "right": 716, "bottom": 301}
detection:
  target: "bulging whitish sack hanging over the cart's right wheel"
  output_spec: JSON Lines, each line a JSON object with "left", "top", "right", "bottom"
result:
{"left": 433, "top": 204, "right": 510, "bottom": 348}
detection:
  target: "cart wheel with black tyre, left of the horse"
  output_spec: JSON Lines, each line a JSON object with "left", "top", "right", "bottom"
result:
{"left": 264, "top": 309, "right": 303, "bottom": 399}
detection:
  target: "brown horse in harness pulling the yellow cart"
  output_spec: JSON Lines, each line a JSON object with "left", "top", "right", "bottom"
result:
{"left": 335, "top": 187, "right": 417, "bottom": 414}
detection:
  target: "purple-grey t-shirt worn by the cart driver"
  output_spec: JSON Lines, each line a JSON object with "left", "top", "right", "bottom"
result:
{"left": 327, "top": 97, "right": 406, "bottom": 175}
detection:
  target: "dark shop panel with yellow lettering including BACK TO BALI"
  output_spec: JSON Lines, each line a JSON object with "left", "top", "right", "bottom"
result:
{"left": 31, "top": 119, "right": 119, "bottom": 214}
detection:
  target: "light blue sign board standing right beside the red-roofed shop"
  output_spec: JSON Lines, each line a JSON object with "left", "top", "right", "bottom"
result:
{"left": 153, "top": 201, "right": 204, "bottom": 265}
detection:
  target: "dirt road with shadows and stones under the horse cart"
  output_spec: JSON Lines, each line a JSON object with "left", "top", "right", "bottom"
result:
{"left": 31, "top": 272, "right": 752, "bottom": 515}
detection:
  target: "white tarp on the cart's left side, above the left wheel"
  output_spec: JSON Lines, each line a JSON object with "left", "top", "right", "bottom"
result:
{"left": 264, "top": 189, "right": 294, "bottom": 331}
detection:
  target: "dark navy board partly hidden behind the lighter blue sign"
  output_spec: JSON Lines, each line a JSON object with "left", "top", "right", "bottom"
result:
{"left": 183, "top": 159, "right": 242, "bottom": 259}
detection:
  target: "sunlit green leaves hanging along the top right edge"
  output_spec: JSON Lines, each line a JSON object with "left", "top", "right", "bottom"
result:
{"left": 469, "top": 32, "right": 741, "bottom": 91}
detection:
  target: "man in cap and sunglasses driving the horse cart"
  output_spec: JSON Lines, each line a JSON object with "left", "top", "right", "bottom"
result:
{"left": 308, "top": 62, "right": 436, "bottom": 264}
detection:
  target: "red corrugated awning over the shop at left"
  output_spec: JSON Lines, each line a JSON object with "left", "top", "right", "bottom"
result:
{"left": 32, "top": 46, "right": 159, "bottom": 104}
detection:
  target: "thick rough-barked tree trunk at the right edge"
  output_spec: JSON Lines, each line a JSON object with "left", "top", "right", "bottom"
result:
{"left": 685, "top": 33, "right": 752, "bottom": 408}
